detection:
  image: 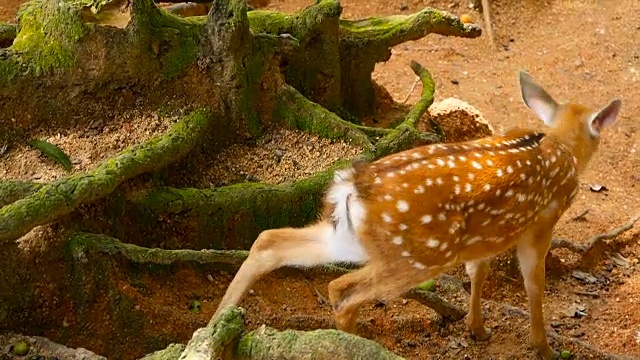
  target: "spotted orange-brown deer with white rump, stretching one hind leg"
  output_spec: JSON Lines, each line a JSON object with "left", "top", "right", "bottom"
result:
{"left": 213, "top": 70, "right": 622, "bottom": 359}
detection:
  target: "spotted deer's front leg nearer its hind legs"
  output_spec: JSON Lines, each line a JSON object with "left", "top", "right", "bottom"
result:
{"left": 465, "top": 260, "right": 491, "bottom": 340}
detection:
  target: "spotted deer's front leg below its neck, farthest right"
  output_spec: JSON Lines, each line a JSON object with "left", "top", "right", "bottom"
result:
{"left": 518, "top": 227, "right": 556, "bottom": 359}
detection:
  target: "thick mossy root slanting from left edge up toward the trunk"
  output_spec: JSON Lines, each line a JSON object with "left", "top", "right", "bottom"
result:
{"left": 0, "top": 111, "right": 212, "bottom": 241}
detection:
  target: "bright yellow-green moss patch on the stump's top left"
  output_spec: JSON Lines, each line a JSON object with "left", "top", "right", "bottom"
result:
{"left": 10, "top": 0, "right": 87, "bottom": 75}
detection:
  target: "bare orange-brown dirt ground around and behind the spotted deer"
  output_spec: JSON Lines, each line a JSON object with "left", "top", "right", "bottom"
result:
{"left": 0, "top": 0, "right": 640, "bottom": 359}
